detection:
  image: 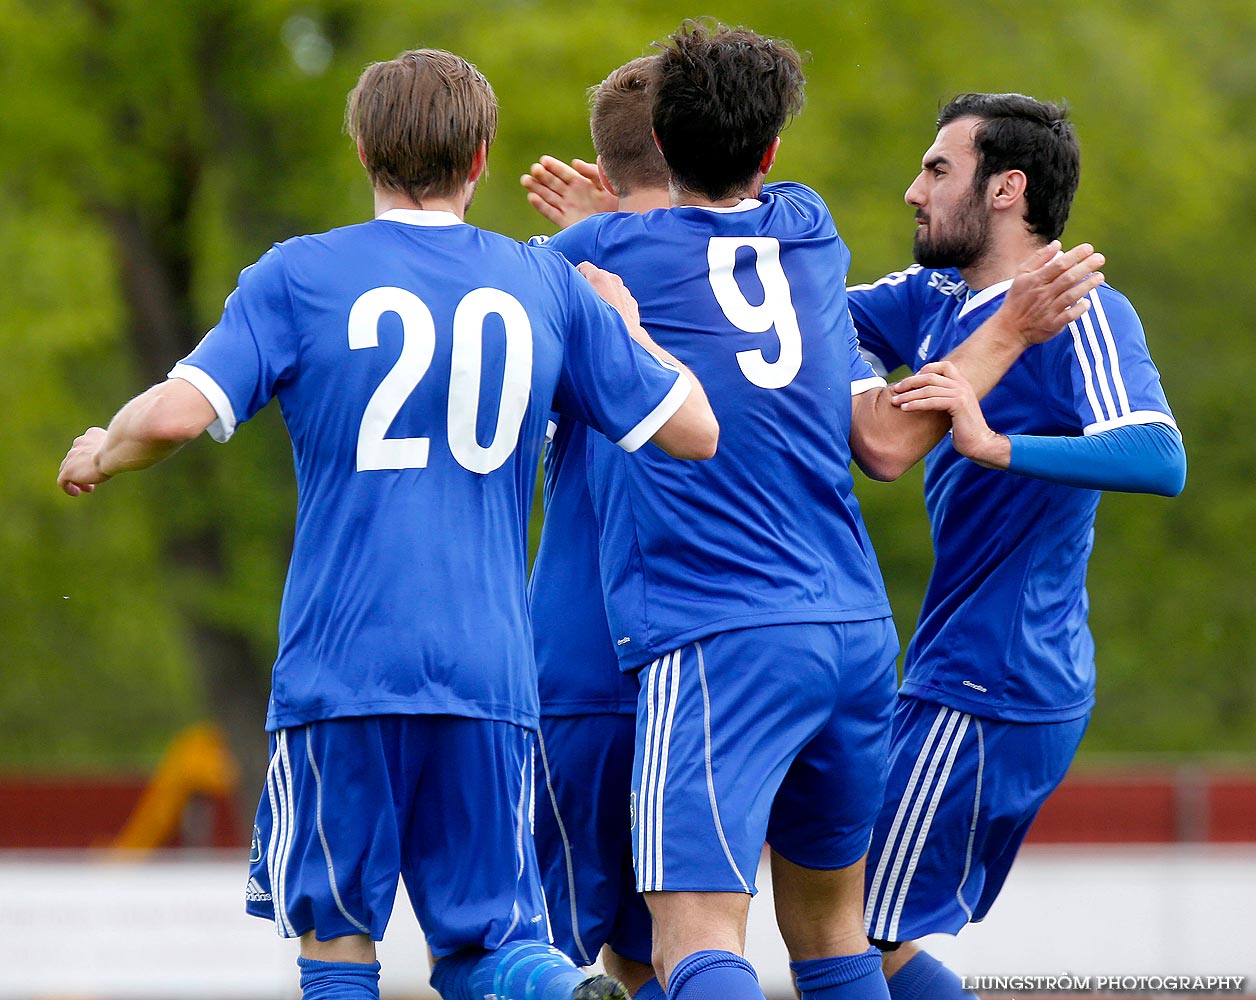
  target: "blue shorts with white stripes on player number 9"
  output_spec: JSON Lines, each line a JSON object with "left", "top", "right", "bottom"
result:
{"left": 633, "top": 618, "right": 898, "bottom": 893}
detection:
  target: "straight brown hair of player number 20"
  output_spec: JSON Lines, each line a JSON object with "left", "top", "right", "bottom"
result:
{"left": 344, "top": 49, "right": 497, "bottom": 202}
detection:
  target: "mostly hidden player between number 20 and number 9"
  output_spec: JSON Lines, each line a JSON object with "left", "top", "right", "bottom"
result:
{"left": 521, "top": 55, "right": 668, "bottom": 992}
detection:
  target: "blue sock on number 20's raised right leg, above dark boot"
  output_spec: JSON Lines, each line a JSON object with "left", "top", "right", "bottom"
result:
{"left": 432, "top": 941, "right": 588, "bottom": 1000}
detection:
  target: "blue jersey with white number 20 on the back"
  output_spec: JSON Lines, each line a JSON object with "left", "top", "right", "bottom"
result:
{"left": 171, "top": 210, "right": 688, "bottom": 730}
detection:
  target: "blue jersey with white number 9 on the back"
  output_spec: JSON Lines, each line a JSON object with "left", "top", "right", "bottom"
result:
{"left": 546, "top": 183, "right": 889, "bottom": 670}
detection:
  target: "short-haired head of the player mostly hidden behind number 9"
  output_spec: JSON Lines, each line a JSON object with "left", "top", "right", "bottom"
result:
{"left": 589, "top": 55, "right": 667, "bottom": 195}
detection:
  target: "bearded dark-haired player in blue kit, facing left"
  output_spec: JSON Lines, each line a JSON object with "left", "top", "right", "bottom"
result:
{"left": 849, "top": 94, "right": 1186, "bottom": 1000}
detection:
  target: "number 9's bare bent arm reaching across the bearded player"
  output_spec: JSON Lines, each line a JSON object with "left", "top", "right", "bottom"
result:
{"left": 850, "top": 242, "right": 1104, "bottom": 481}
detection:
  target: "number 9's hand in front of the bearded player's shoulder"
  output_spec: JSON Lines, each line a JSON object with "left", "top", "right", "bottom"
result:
{"left": 1000, "top": 240, "right": 1105, "bottom": 344}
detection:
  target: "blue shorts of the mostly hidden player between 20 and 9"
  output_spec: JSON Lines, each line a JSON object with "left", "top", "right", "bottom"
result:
{"left": 536, "top": 712, "right": 651, "bottom": 965}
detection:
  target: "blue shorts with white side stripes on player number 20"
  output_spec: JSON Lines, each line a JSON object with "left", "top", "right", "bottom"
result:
{"left": 245, "top": 715, "right": 549, "bottom": 956}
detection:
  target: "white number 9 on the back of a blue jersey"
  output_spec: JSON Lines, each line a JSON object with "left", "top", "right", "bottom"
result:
{"left": 707, "top": 236, "right": 803, "bottom": 389}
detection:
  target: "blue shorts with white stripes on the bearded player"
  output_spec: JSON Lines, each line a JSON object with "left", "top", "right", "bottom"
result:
{"left": 864, "top": 695, "right": 1089, "bottom": 941}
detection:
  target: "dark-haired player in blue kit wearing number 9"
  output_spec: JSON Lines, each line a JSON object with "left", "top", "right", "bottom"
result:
{"left": 535, "top": 24, "right": 1099, "bottom": 1000}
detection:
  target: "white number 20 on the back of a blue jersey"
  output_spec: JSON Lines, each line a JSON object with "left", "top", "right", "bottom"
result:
{"left": 349, "top": 286, "right": 533, "bottom": 474}
